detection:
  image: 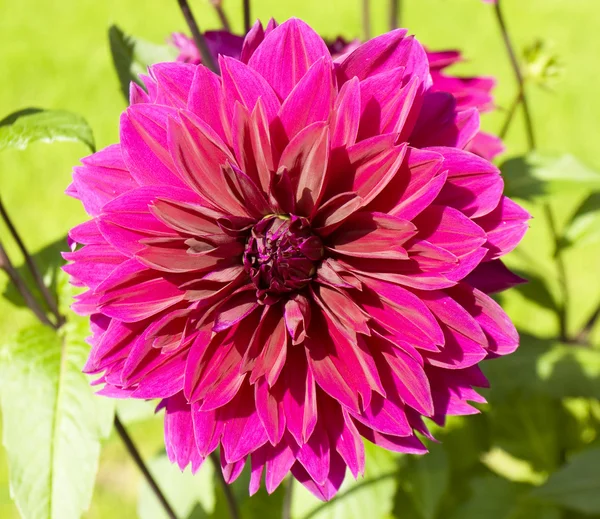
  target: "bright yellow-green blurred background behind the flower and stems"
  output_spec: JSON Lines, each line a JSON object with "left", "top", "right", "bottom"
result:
{"left": 0, "top": 0, "right": 600, "bottom": 519}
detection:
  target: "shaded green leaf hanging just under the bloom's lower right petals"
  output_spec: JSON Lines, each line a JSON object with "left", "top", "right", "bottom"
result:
{"left": 400, "top": 443, "right": 450, "bottom": 519}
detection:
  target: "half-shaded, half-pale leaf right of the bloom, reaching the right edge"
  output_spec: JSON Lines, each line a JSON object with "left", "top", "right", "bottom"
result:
{"left": 500, "top": 153, "right": 600, "bottom": 200}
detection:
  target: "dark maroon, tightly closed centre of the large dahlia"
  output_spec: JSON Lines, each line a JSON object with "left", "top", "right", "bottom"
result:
{"left": 244, "top": 215, "right": 323, "bottom": 304}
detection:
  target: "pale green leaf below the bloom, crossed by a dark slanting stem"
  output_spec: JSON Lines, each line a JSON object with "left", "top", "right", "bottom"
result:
{"left": 138, "top": 454, "right": 215, "bottom": 519}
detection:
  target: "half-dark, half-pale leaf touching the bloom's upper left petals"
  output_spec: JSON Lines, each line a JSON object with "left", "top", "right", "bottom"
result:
{"left": 108, "top": 25, "right": 177, "bottom": 103}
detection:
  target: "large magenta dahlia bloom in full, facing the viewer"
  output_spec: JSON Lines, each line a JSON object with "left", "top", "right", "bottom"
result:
{"left": 65, "top": 19, "right": 529, "bottom": 499}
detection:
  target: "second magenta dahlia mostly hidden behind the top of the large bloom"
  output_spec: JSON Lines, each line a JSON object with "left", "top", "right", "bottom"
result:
{"left": 172, "top": 25, "right": 504, "bottom": 160}
